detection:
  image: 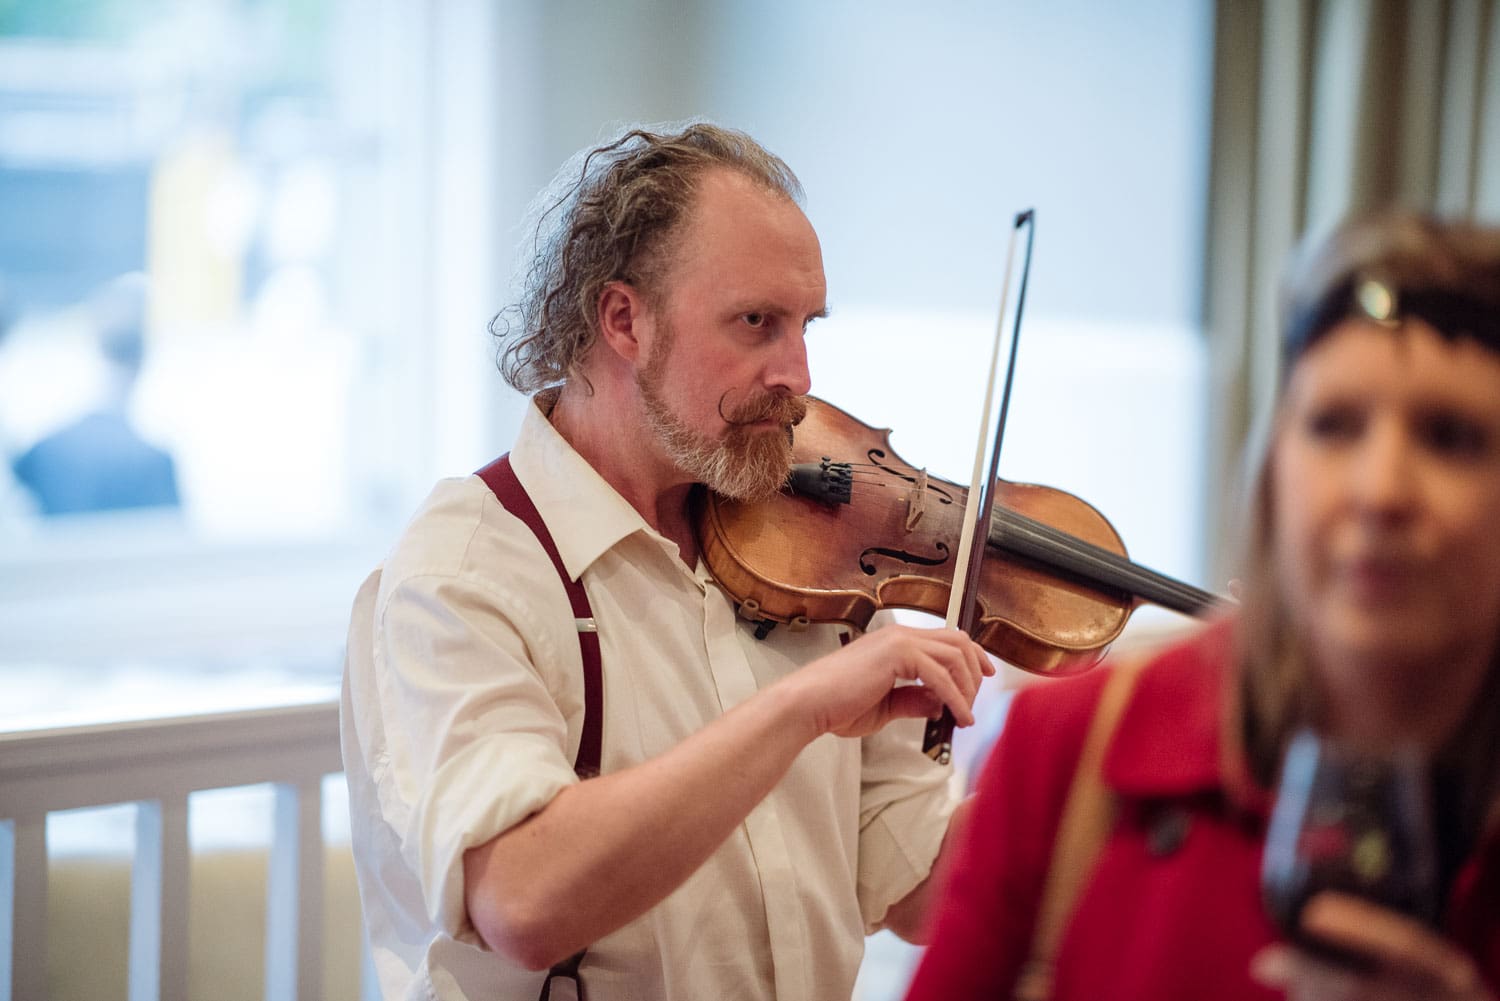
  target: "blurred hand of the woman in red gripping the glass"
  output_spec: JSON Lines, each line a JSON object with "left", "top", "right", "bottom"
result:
{"left": 1251, "top": 891, "right": 1496, "bottom": 1001}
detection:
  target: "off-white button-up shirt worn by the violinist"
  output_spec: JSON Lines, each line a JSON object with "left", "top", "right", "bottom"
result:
{"left": 342, "top": 404, "right": 954, "bottom": 1001}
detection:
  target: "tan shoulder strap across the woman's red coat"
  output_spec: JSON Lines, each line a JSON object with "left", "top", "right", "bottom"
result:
{"left": 1014, "top": 663, "right": 1140, "bottom": 1001}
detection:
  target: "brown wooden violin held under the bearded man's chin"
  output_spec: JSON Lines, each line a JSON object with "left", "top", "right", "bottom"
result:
{"left": 695, "top": 398, "right": 1221, "bottom": 675}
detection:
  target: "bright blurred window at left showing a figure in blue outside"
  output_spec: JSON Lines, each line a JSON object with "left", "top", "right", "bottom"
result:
{"left": 0, "top": 0, "right": 383, "bottom": 536}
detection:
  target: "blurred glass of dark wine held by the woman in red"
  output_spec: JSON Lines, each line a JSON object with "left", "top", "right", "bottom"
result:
{"left": 1262, "top": 731, "right": 1437, "bottom": 966}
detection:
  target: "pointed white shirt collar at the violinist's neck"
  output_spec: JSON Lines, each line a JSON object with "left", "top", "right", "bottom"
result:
{"left": 510, "top": 398, "right": 656, "bottom": 581}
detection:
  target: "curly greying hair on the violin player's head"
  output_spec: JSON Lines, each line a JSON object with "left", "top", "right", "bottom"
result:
{"left": 489, "top": 122, "right": 803, "bottom": 393}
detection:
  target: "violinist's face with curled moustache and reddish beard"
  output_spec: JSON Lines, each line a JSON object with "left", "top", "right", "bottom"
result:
{"left": 636, "top": 171, "right": 827, "bottom": 500}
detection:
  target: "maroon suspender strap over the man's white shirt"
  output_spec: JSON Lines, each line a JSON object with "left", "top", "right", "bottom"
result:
{"left": 479, "top": 452, "right": 605, "bottom": 1001}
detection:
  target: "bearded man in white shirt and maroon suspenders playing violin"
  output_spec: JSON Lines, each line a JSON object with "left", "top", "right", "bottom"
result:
{"left": 344, "top": 123, "right": 993, "bottom": 1001}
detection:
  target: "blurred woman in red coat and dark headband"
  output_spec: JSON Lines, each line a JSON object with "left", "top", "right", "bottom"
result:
{"left": 909, "top": 216, "right": 1500, "bottom": 1001}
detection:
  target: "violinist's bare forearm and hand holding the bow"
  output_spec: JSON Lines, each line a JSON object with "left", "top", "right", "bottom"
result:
{"left": 464, "top": 626, "right": 993, "bottom": 969}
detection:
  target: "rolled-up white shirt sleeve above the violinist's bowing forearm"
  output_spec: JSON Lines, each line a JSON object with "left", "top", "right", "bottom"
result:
{"left": 363, "top": 573, "right": 582, "bottom": 941}
